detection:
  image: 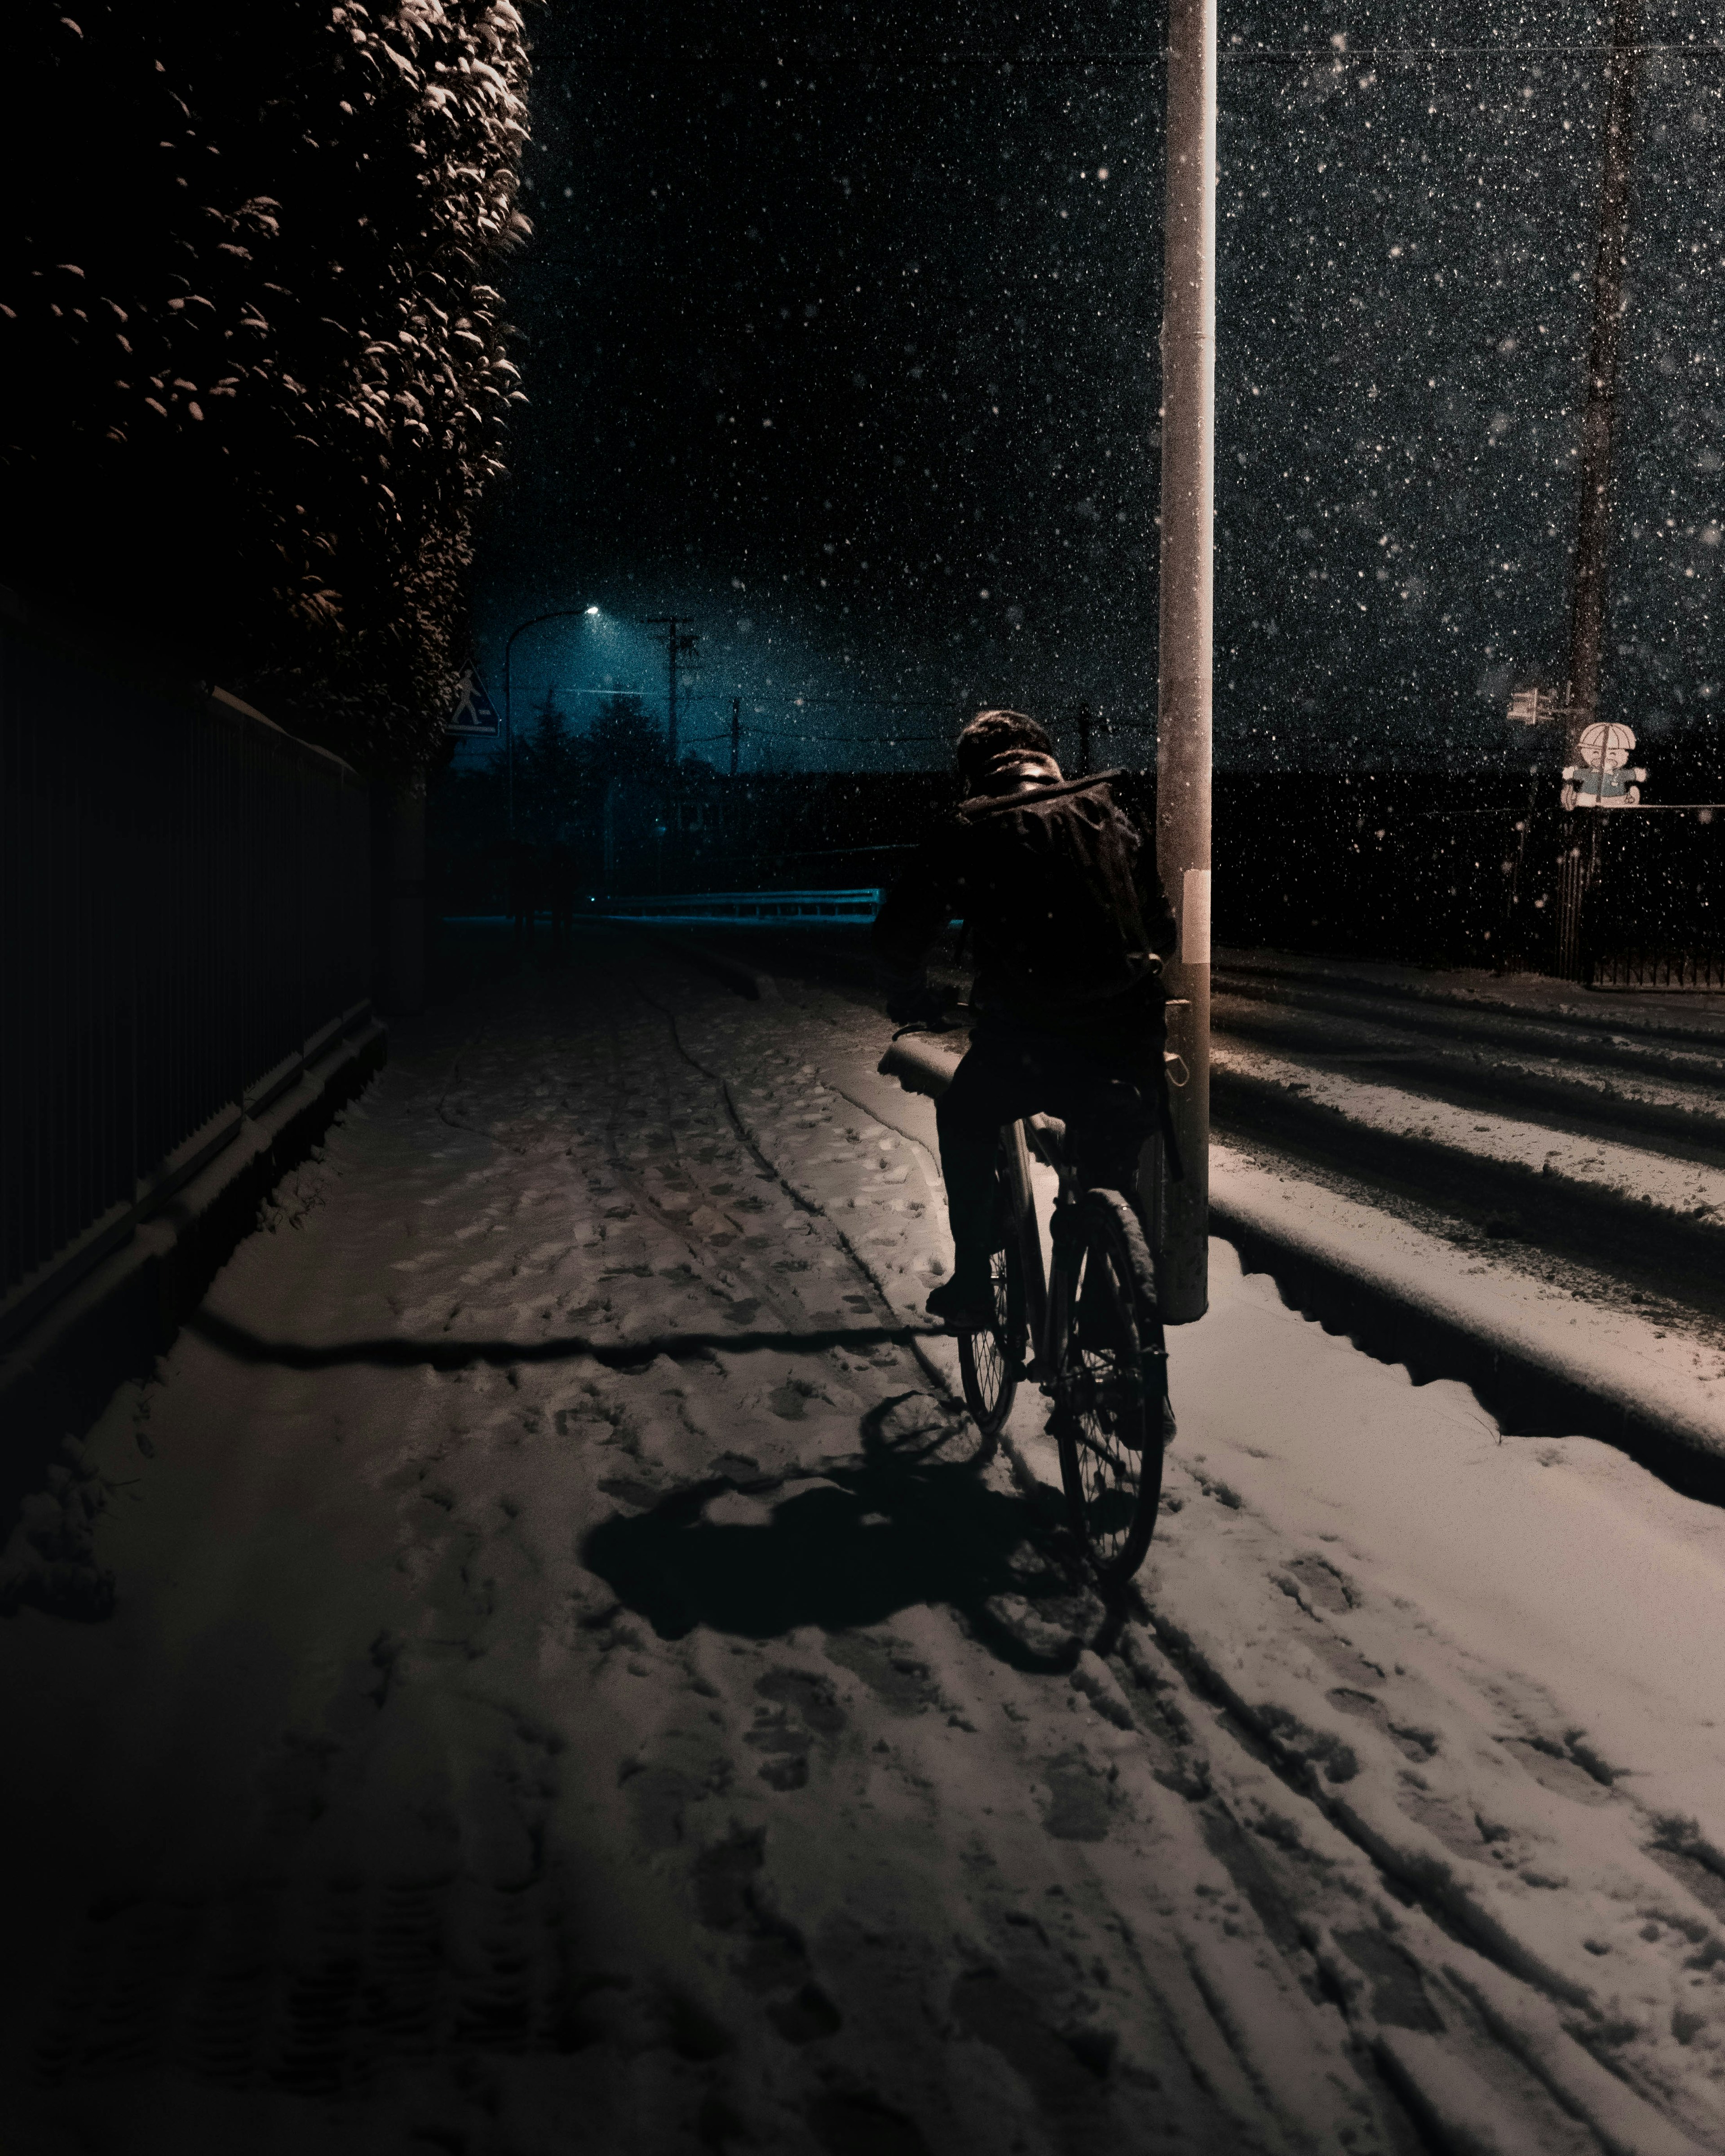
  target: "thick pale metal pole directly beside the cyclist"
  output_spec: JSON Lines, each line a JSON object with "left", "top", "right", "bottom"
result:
{"left": 1156, "top": 0, "right": 1216, "bottom": 1324}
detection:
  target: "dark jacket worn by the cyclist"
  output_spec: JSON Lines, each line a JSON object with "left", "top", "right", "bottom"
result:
{"left": 873, "top": 750, "right": 1175, "bottom": 1035}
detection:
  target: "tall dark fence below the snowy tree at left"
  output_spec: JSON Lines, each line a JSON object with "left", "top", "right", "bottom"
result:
{"left": 0, "top": 597, "right": 371, "bottom": 1337}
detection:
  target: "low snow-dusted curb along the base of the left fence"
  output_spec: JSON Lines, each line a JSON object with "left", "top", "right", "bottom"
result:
{"left": 0, "top": 1018, "right": 388, "bottom": 1542}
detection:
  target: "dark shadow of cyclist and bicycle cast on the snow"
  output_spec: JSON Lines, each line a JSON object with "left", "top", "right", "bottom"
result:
{"left": 580, "top": 1395, "right": 1104, "bottom": 1671}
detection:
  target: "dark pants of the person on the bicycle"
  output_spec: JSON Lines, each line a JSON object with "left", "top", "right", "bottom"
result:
{"left": 933, "top": 1020, "right": 1162, "bottom": 1278}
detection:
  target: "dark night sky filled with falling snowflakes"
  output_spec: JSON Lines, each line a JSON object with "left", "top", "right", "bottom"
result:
{"left": 479, "top": 0, "right": 1725, "bottom": 791}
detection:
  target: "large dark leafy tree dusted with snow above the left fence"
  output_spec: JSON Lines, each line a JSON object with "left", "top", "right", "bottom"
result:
{"left": 0, "top": 0, "right": 528, "bottom": 772}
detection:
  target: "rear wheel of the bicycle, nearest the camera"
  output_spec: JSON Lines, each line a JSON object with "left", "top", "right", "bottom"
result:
{"left": 1054, "top": 1190, "right": 1169, "bottom": 1587}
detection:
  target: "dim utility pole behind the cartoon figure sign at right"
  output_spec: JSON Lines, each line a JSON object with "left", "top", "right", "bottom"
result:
{"left": 1557, "top": 0, "right": 1641, "bottom": 981}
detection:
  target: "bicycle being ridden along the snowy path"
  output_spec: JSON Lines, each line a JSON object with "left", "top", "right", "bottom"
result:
{"left": 957, "top": 1115, "right": 1169, "bottom": 1589}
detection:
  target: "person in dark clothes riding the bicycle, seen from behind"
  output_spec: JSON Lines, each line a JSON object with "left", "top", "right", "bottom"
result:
{"left": 873, "top": 711, "right": 1175, "bottom": 1332}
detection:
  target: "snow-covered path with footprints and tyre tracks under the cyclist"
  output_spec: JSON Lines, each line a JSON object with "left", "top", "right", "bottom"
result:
{"left": 0, "top": 932, "right": 1725, "bottom": 2156}
